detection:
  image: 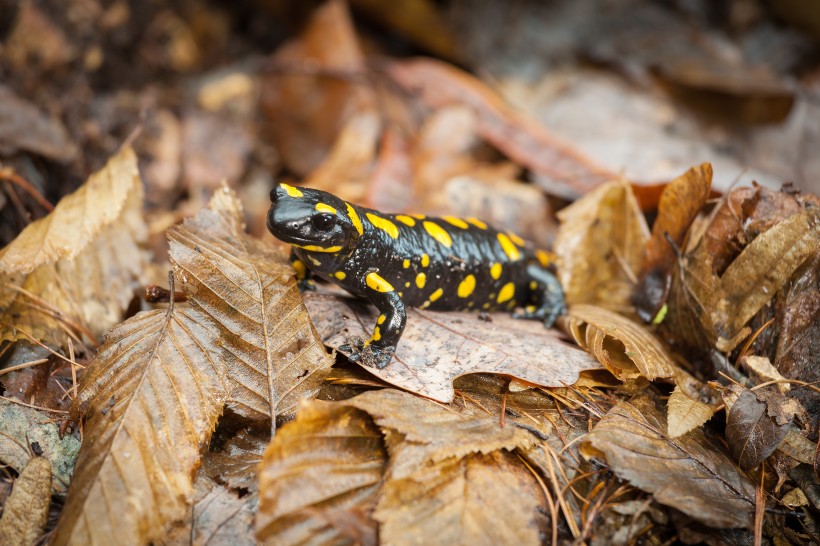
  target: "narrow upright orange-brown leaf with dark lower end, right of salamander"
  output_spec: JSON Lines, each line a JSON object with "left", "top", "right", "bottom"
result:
{"left": 633, "top": 163, "right": 712, "bottom": 322}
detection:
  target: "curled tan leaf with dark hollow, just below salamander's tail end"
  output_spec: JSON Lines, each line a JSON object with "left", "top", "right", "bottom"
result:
{"left": 566, "top": 304, "right": 681, "bottom": 381}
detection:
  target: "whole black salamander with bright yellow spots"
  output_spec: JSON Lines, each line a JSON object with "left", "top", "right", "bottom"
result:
{"left": 267, "top": 184, "right": 566, "bottom": 368}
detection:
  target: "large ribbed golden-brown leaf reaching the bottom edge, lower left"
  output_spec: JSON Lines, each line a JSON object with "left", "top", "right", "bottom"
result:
{"left": 53, "top": 305, "right": 227, "bottom": 545}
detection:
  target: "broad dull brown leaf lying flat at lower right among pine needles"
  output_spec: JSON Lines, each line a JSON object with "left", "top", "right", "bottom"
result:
{"left": 584, "top": 398, "right": 755, "bottom": 528}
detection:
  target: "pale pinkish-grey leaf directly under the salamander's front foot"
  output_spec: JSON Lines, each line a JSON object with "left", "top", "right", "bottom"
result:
{"left": 305, "top": 294, "right": 599, "bottom": 402}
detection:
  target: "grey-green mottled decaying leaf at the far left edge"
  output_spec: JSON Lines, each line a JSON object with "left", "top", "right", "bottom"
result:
{"left": 0, "top": 398, "right": 80, "bottom": 493}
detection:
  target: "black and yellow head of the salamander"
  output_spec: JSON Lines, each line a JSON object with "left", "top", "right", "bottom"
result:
{"left": 267, "top": 184, "right": 361, "bottom": 253}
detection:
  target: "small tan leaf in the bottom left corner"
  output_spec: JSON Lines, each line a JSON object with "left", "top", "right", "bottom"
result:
{"left": 0, "top": 457, "right": 51, "bottom": 546}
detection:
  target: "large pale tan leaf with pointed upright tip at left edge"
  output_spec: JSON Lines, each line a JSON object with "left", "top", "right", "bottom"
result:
{"left": 0, "top": 144, "right": 147, "bottom": 345}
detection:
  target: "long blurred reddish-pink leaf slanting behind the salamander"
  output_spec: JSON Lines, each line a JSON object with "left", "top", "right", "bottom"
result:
{"left": 387, "top": 58, "right": 618, "bottom": 195}
